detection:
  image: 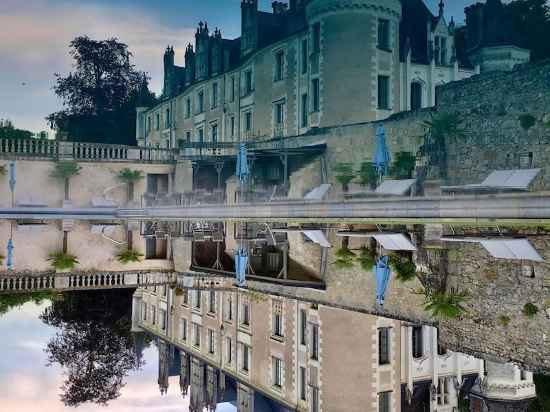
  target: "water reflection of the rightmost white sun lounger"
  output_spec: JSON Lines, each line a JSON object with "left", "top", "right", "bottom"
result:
{"left": 441, "top": 237, "right": 544, "bottom": 262}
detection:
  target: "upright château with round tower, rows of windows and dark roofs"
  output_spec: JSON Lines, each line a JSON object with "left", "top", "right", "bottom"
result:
{"left": 136, "top": 0, "right": 529, "bottom": 148}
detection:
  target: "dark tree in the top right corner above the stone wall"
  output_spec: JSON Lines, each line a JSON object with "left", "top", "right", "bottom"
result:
{"left": 505, "top": 0, "right": 550, "bottom": 61}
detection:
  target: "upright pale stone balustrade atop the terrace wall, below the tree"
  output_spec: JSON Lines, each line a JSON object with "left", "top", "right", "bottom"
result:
{"left": 0, "top": 139, "right": 176, "bottom": 163}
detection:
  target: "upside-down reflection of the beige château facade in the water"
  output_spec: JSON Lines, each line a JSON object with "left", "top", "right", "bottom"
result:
{"left": 130, "top": 286, "right": 532, "bottom": 412}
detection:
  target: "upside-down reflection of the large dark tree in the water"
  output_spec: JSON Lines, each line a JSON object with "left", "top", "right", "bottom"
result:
{"left": 41, "top": 290, "right": 143, "bottom": 406}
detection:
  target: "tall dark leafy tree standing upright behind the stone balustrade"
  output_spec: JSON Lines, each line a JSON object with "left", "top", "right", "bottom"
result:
{"left": 47, "top": 36, "right": 154, "bottom": 144}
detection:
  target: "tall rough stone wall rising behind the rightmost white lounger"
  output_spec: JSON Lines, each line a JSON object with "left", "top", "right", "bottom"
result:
{"left": 437, "top": 61, "right": 550, "bottom": 188}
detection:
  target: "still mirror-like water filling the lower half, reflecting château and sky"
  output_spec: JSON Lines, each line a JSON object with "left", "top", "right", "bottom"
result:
{"left": 0, "top": 222, "right": 550, "bottom": 412}
